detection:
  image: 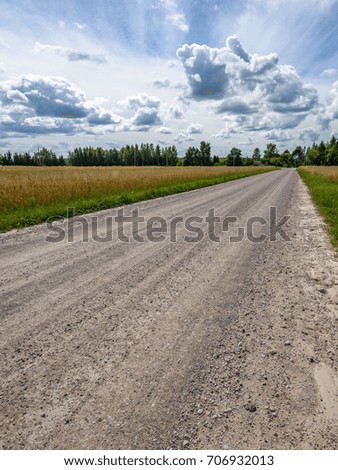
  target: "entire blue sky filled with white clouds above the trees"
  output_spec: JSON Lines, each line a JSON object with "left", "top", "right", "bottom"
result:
{"left": 0, "top": 0, "right": 338, "bottom": 155}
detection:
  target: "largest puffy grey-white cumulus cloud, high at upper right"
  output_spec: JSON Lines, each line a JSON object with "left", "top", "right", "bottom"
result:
{"left": 177, "top": 36, "right": 318, "bottom": 114}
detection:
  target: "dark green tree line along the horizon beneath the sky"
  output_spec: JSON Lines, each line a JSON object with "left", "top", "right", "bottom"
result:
{"left": 0, "top": 137, "right": 338, "bottom": 167}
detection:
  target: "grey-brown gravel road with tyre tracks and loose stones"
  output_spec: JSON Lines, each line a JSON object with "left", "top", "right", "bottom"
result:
{"left": 0, "top": 170, "right": 338, "bottom": 449}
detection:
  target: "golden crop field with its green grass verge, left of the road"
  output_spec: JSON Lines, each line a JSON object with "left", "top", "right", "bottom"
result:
{"left": 0, "top": 166, "right": 275, "bottom": 232}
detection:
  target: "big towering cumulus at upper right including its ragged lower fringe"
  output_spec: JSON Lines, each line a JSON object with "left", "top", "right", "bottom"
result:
{"left": 177, "top": 36, "right": 320, "bottom": 130}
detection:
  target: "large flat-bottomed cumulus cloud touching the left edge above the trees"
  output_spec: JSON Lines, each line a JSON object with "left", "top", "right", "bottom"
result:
{"left": 0, "top": 75, "right": 121, "bottom": 134}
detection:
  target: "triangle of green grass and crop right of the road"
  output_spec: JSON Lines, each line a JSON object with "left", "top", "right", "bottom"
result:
{"left": 298, "top": 167, "right": 338, "bottom": 250}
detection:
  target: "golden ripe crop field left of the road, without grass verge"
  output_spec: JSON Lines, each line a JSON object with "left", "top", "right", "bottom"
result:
{"left": 0, "top": 166, "right": 274, "bottom": 210}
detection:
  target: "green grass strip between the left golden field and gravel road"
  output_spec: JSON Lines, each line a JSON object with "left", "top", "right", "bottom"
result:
{"left": 0, "top": 168, "right": 277, "bottom": 232}
